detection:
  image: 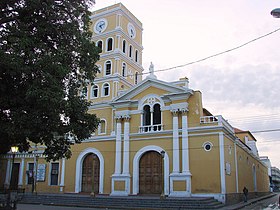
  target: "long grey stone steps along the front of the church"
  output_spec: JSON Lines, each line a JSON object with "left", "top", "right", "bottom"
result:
{"left": 20, "top": 194, "right": 224, "bottom": 209}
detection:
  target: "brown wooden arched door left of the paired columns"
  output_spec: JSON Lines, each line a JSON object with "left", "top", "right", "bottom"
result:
{"left": 82, "top": 153, "right": 100, "bottom": 194}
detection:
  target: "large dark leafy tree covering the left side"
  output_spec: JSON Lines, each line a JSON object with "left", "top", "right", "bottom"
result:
{"left": 0, "top": 0, "right": 100, "bottom": 160}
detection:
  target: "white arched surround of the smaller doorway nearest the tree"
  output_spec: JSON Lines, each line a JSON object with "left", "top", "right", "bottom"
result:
{"left": 75, "top": 148, "right": 104, "bottom": 194}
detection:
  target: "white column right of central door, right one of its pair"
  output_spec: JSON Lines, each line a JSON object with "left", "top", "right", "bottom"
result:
{"left": 182, "top": 110, "right": 190, "bottom": 173}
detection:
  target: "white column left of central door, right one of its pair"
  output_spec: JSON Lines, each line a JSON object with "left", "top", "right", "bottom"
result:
{"left": 123, "top": 117, "right": 130, "bottom": 175}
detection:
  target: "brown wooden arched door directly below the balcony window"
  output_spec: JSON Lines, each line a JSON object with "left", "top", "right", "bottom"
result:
{"left": 139, "top": 151, "right": 163, "bottom": 194}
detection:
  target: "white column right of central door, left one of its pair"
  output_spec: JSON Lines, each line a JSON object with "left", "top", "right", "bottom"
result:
{"left": 172, "top": 111, "right": 180, "bottom": 173}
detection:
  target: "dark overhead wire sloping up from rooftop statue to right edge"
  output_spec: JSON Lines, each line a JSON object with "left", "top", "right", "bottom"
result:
{"left": 141, "top": 28, "right": 280, "bottom": 75}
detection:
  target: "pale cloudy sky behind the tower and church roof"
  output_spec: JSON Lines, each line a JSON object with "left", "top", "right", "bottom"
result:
{"left": 93, "top": 0, "right": 280, "bottom": 168}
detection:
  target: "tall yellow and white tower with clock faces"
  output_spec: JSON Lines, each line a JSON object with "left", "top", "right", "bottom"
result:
{"left": 89, "top": 3, "right": 143, "bottom": 102}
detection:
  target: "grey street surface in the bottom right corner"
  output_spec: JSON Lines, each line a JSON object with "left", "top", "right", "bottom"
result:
{"left": 242, "top": 193, "right": 280, "bottom": 210}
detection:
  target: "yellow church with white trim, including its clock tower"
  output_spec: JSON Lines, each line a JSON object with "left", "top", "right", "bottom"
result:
{"left": 0, "top": 3, "right": 269, "bottom": 203}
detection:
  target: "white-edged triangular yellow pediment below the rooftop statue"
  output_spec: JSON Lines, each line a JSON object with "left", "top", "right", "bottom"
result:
{"left": 114, "top": 78, "right": 192, "bottom": 102}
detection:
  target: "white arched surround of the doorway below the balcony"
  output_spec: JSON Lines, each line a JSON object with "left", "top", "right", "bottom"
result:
{"left": 132, "top": 145, "right": 169, "bottom": 195}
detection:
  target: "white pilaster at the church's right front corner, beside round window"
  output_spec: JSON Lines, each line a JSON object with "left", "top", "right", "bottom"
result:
{"left": 219, "top": 132, "right": 226, "bottom": 194}
